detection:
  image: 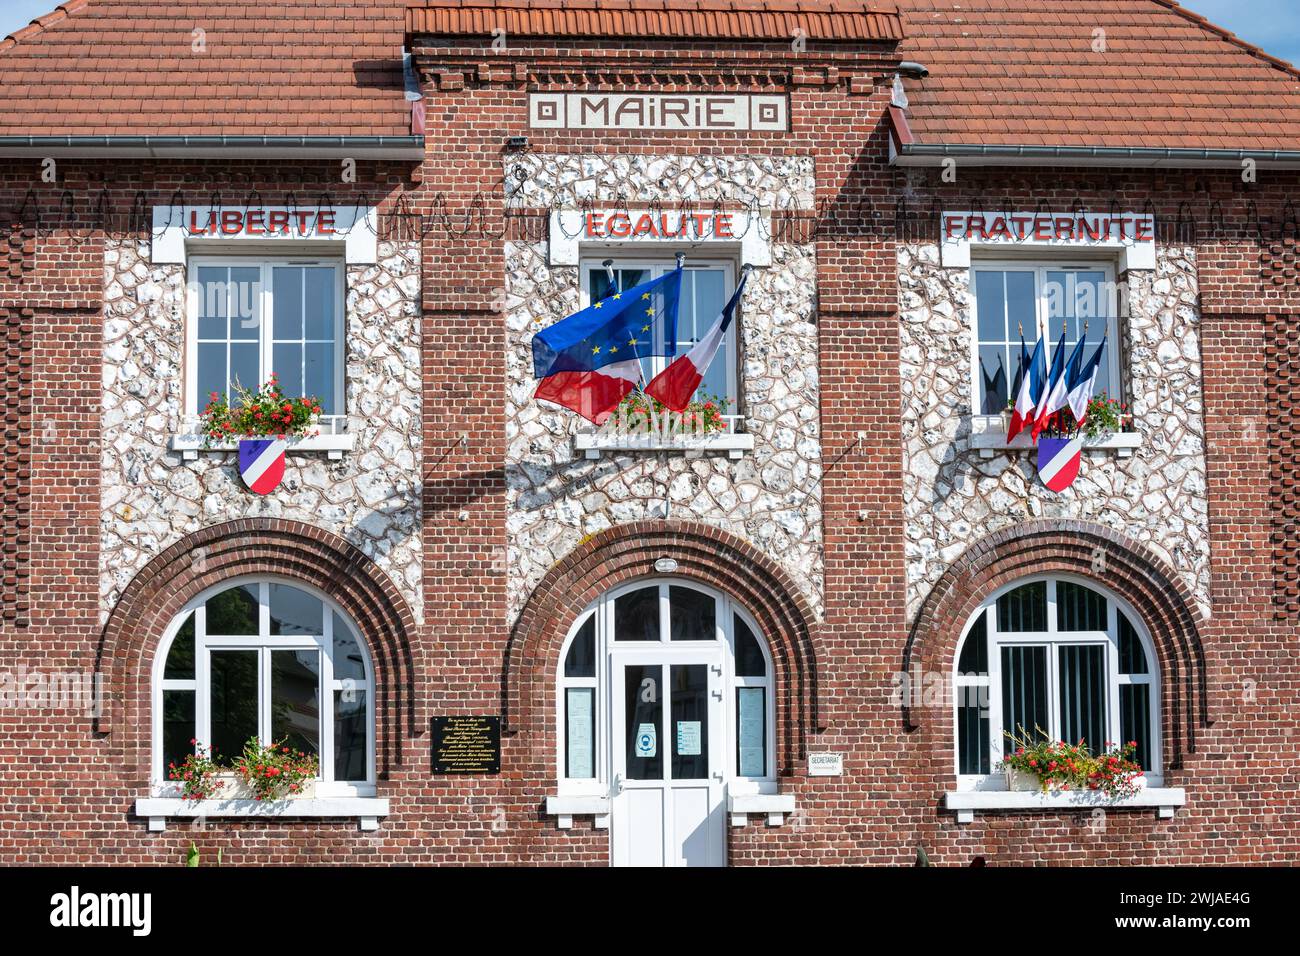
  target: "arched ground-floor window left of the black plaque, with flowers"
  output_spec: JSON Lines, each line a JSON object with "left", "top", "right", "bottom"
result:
{"left": 153, "top": 580, "right": 374, "bottom": 796}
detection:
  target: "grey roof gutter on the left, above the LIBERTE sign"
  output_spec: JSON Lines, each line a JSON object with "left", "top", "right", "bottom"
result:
{"left": 0, "top": 135, "right": 424, "bottom": 160}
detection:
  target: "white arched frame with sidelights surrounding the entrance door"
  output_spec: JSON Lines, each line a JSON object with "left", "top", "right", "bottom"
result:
{"left": 554, "top": 578, "right": 777, "bottom": 797}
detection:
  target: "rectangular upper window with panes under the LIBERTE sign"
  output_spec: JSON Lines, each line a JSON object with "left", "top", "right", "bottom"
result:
{"left": 186, "top": 259, "right": 343, "bottom": 415}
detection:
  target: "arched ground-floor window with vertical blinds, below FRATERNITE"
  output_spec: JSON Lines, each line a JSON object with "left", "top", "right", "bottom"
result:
{"left": 953, "top": 578, "right": 1161, "bottom": 790}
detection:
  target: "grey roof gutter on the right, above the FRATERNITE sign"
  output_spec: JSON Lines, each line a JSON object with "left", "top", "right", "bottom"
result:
{"left": 891, "top": 142, "right": 1300, "bottom": 169}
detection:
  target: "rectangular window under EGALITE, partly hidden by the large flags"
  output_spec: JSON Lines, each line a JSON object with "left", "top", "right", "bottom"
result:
{"left": 582, "top": 259, "right": 740, "bottom": 414}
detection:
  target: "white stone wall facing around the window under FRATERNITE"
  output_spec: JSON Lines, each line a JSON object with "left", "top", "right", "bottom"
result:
{"left": 898, "top": 243, "right": 1209, "bottom": 619}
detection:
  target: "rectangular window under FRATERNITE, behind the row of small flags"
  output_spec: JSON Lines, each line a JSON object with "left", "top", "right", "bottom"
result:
{"left": 971, "top": 263, "right": 1121, "bottom": 415}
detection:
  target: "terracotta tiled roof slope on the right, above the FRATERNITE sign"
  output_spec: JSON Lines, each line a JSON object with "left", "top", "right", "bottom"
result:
{"left": 898, "top": 0, "right": 1300, "bottom": 150}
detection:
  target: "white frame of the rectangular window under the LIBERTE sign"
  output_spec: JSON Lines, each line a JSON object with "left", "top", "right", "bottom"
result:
{"left": 185, "top": 255, "right": 347, "bottom": 418}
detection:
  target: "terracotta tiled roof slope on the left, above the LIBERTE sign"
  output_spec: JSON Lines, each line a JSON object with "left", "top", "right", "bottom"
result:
{"left": 0, "top": 0, "right": 411, "bottom": 135}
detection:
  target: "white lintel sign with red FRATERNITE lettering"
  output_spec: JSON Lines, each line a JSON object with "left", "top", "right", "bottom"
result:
{"left": 943, "top": 212, "right": 1156, "bottom": 271}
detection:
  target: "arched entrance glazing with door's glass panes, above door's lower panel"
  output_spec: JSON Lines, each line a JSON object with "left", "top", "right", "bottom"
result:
{"left": 555, "top": 580, "right": 776, "bottom": 795}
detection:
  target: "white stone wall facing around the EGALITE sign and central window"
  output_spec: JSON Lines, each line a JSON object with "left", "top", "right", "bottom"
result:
{"left": 506, "top": 155, "right": 823, "bottom": 620}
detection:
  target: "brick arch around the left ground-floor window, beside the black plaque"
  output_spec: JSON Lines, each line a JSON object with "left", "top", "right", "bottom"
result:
{"left": 96, "top": 518, "right": 417, "bottom": 786}
